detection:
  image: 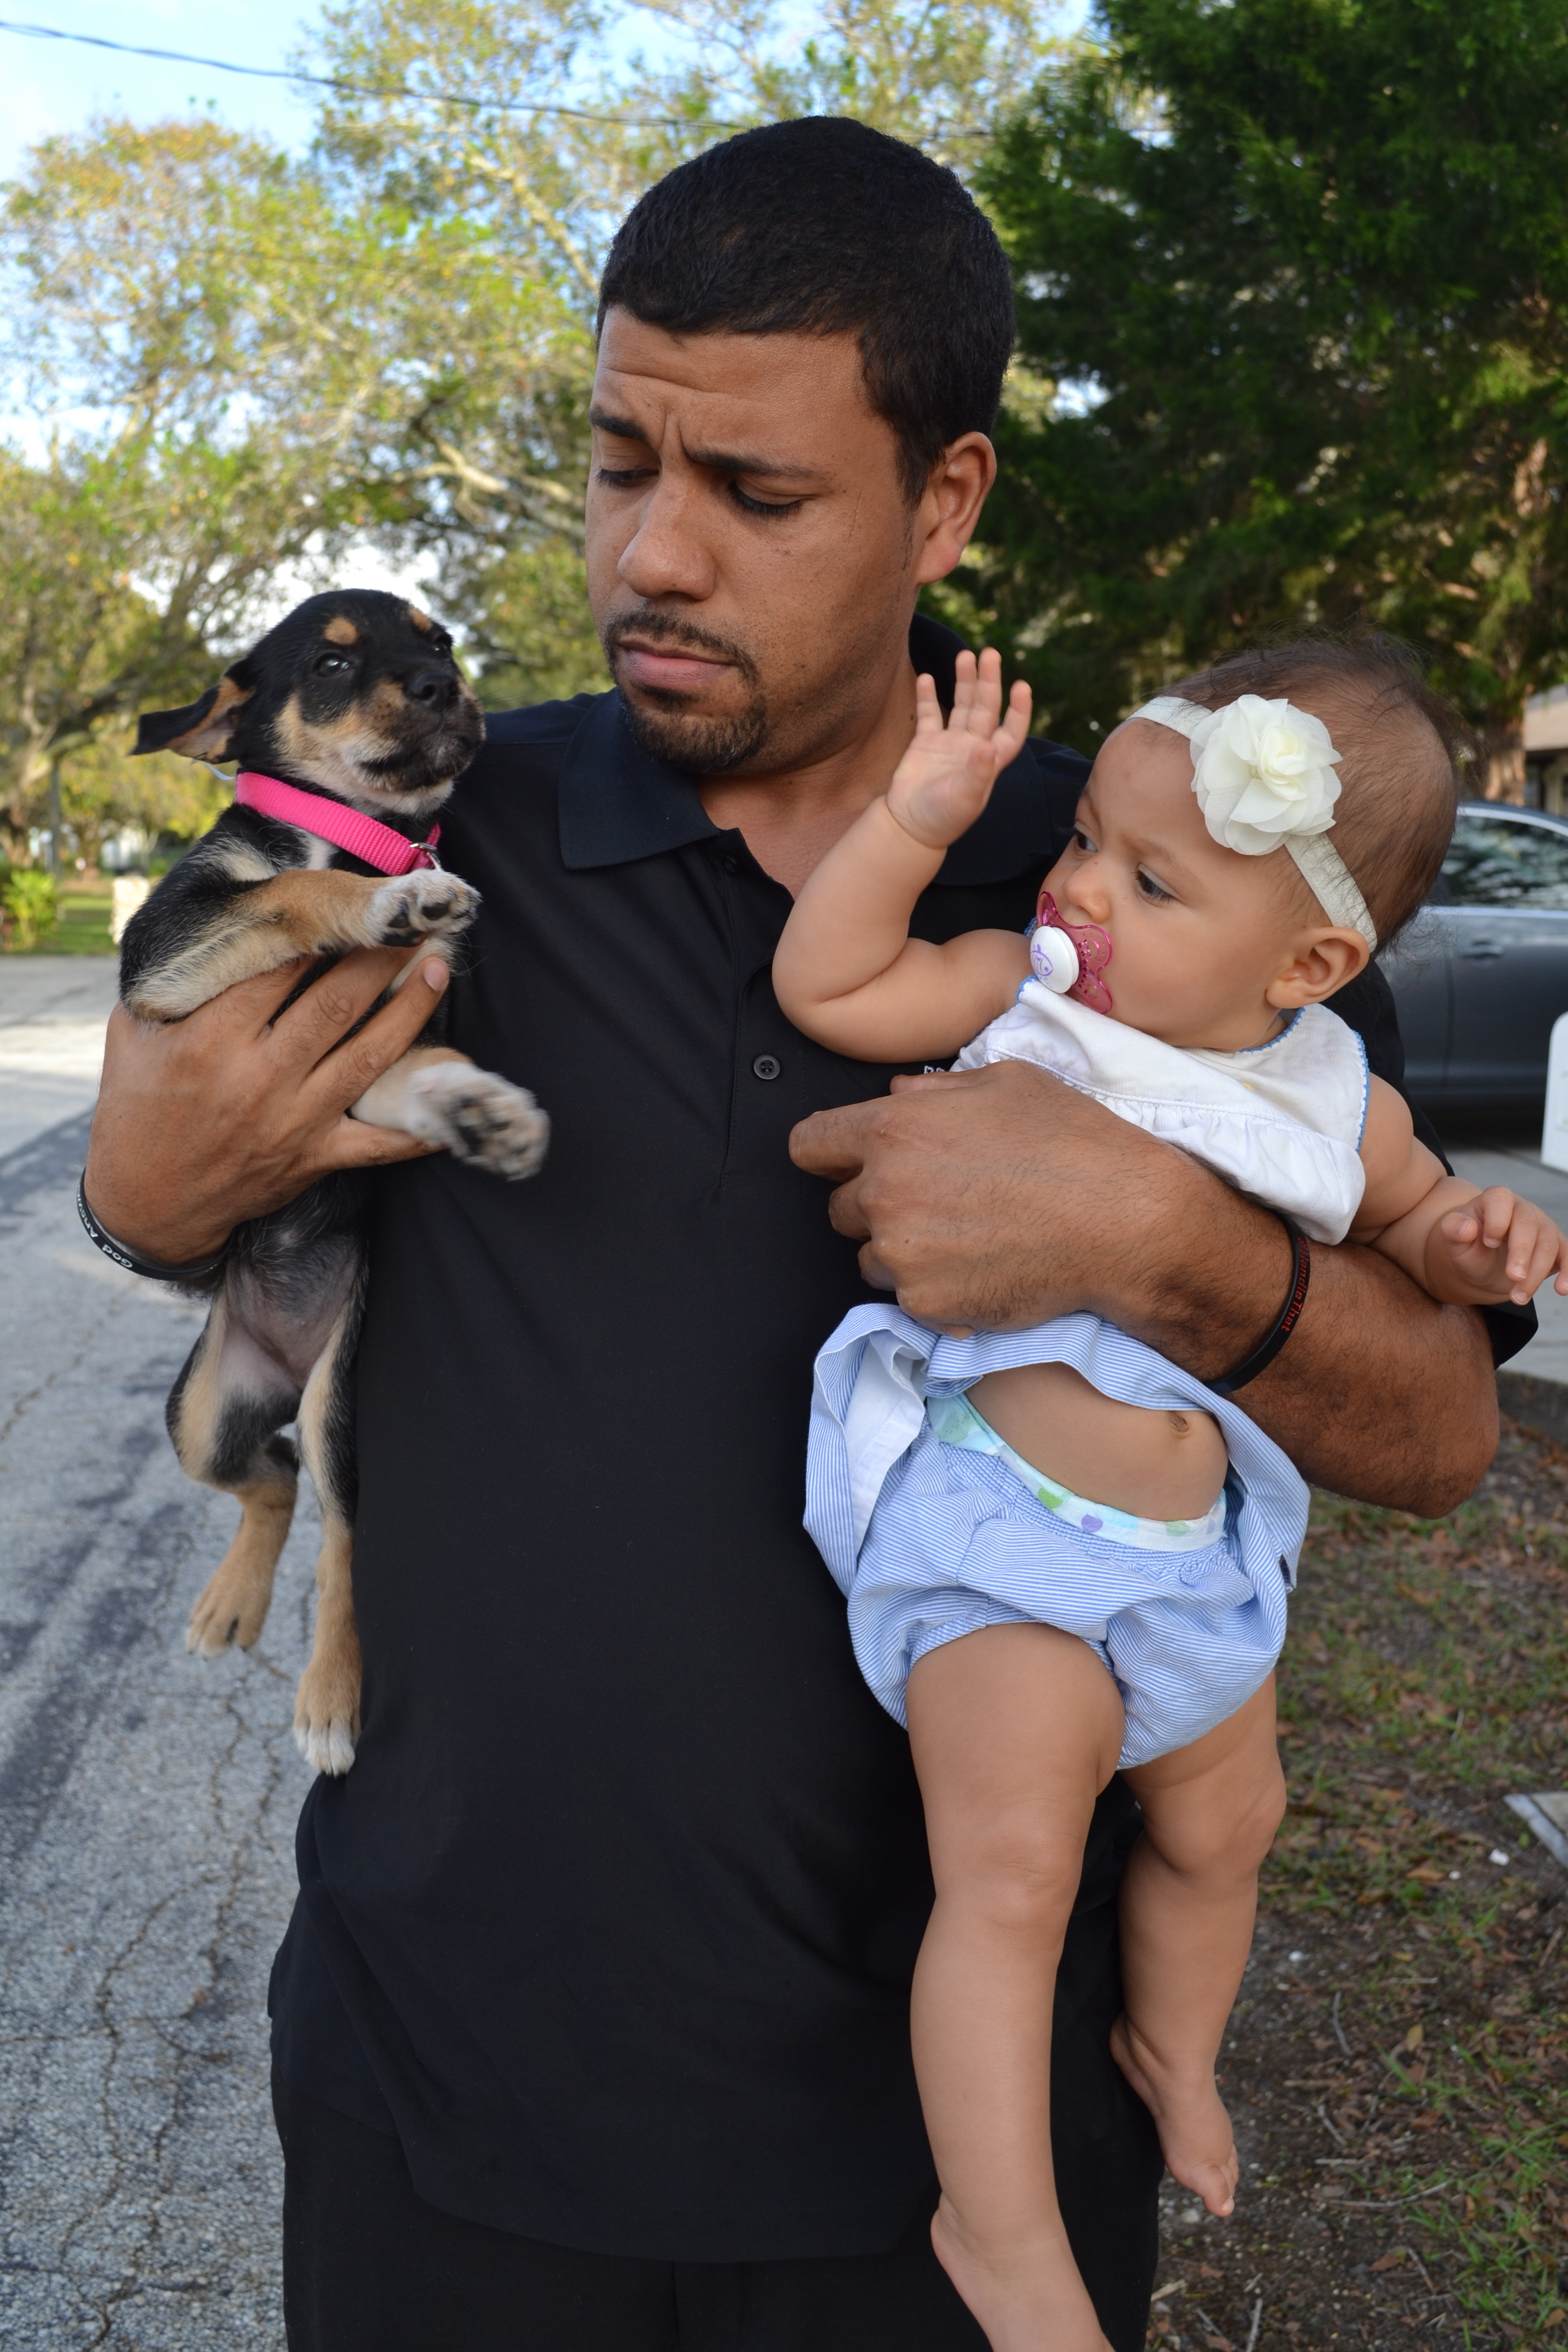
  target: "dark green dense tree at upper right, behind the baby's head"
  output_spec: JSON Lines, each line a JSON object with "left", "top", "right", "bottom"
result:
{"left": 968, "top": 0, "right": 1568, "bottom": 797}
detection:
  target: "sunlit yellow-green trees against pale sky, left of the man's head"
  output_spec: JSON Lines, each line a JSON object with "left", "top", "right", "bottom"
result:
{"left": 0, "top": 0, "right": 1067, "bottom": 854}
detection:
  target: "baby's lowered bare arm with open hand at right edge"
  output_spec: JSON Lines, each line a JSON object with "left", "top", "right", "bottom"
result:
{"left": 1350, "top": 1077, "right": 1568, "bottom": 1308}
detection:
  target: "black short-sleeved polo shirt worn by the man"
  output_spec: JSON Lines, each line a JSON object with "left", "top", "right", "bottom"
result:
{"left": 273, "top": 621, "right": 1532, "bottom": 2260}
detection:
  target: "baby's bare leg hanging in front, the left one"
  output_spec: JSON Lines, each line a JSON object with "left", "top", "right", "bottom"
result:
{"left": 908, "top": 1625, "right": 1121, "bottom": 2352}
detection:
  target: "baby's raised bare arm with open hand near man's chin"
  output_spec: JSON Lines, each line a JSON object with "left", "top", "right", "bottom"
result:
{"left": 773, "top": 649, "right": 1030, "bottom": 1061}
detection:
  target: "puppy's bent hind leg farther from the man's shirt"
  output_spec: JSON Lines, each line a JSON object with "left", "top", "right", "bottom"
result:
{"left": 167, "top": 1291, "right": 299, "bottom": 1658}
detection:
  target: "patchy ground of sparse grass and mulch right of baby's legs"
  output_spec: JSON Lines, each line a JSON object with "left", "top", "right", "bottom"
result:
{"left": 1149, "top": 1423, "right": 1568, "bottom": 2352}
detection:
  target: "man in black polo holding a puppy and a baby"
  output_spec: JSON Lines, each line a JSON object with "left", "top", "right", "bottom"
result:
{"left": 87, "top": 120, "right": 1528, "bottom": 2352}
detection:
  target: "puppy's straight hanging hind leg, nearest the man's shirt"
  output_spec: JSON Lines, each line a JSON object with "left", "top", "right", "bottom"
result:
{"left": 294, "top": 1275, "right": 364, "bottom": 1773}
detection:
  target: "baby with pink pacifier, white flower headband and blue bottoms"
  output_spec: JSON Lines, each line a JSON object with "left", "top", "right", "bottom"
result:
{"left": 773, "top": 642, "right": 1568, "bottom": 2352}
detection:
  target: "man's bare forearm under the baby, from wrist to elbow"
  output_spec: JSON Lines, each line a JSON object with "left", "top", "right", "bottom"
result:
{"left": 1105, "top": 1197, "right": 1498, "bottom": 1517}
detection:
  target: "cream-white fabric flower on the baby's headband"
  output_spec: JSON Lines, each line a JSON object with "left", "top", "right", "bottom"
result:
{"left": 1189, "top": 694, "right": 1340, "bottom": 859}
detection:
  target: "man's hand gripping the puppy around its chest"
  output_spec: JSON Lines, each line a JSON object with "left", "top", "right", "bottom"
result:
{"left": 87, "top": 948, "right": 447, "bottom": 1265}
